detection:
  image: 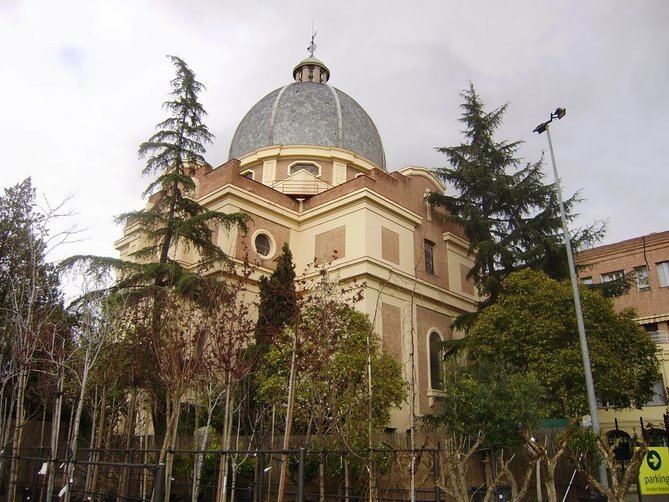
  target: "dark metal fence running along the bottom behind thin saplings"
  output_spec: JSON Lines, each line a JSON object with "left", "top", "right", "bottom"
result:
{"left": 0, "top": 448, "right": 580, "bottom": 502}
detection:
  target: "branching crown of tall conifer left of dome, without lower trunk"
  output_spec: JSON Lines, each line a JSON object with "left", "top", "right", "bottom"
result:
{"left": 65, "top": 56, "right": 245, "bottom": 297}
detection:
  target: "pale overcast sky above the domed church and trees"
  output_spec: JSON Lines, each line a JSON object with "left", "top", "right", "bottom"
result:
{"left": 0, "top": 0, "right": 669, "bottom": 260}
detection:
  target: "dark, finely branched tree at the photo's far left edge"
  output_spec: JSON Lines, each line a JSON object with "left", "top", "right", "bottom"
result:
{"left": 0, "top": 180, "right": 76, "bottom": 501}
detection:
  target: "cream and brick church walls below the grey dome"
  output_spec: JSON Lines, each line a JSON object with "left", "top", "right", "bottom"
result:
{"left": 116, "top": 146, "right": 475, "bottom": 430}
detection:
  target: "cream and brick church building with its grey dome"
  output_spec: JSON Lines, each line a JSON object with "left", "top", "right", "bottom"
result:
{"left": 116, "top": 53, "right": 476, "bottom": 431}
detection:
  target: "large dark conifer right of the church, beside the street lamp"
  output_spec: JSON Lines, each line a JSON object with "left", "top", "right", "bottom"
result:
{"left": 428, "top": 84, "right": 604, "bottom": 327}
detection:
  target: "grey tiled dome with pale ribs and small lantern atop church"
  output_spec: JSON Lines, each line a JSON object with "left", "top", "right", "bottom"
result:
{"left": 230, "top": 56, "right": 386, "bottom": 170}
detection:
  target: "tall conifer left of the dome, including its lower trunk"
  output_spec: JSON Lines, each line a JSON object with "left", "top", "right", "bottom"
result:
{"left": 62, "top": 56, "right": 246, "bottom": 452}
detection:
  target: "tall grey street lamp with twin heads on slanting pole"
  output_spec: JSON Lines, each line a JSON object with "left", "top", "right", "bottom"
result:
{"left": 532, "top": 108, "right": 608, "bottom": 486}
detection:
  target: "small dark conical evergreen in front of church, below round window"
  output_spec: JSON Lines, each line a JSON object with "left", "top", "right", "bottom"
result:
{"left": 255, "top": 244, "right": 297, "bottom": 345}
